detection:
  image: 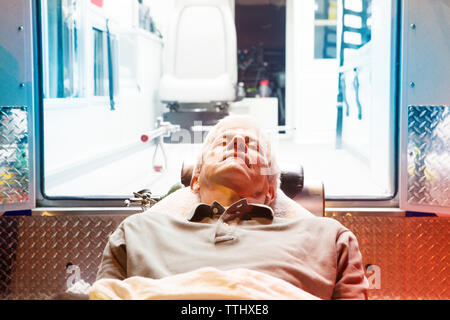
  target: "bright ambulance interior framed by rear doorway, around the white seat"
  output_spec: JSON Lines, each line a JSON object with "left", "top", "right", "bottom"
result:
{"left": 40, "top": 0, "right": 397, "bottom": 201}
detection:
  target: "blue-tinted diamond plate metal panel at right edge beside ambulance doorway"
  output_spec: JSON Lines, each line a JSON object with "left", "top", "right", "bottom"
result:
{"left": 407, "top": 106, "right": 450, "bottom": 207}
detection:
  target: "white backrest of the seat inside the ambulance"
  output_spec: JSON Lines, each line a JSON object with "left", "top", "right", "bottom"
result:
{"left": 159, "top": 0, "right": 237, "bottom": 103}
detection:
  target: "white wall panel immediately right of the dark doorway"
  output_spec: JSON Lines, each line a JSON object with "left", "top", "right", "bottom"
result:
{"left": 286, "top": 0, "right": 338, "bottom": 143}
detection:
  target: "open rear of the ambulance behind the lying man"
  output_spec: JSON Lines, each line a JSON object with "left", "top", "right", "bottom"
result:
{"left": 0, "top": 0, "right": 450, "bottom": 299}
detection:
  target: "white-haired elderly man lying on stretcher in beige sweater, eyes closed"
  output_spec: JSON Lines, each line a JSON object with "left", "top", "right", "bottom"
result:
{"left": 97, "top": 116, "right": 368, "bottom": 299}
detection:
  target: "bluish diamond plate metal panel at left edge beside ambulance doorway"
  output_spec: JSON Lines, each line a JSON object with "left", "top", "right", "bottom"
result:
{"left": 0, "top": 106, "right": 30, "bottom": 204}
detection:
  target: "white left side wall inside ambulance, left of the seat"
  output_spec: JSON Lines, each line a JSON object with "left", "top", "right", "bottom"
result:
{"left": 44, "top": 2, "right": 163, "bottom": 179}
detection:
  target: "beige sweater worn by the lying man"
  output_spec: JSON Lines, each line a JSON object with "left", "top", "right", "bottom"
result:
{"left": 97, "top": 190, "right": 368, "bottom": 299}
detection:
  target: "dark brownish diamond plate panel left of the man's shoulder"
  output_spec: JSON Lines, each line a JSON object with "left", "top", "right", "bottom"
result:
{"left": 0, "top": 216, "right": 124, "bottom": 299}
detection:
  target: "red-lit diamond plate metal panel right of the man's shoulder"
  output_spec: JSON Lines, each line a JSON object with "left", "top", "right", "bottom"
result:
{"left": 334, "top": 216, "right": 450, "bottom": 300}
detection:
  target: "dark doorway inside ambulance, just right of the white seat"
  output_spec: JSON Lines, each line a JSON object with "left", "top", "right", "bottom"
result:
{"left": 235, "top": 0, "right": 286, "bottom": 126}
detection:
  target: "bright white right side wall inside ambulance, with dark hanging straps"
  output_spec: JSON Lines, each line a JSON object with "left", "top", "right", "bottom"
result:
{"left": 342, "top": 1, "right": 396, "bottom": 195}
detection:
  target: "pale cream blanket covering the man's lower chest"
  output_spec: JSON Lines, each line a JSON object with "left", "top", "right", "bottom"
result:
{"left": 89, "top": 267, "right": 319, "bottom": 300}
